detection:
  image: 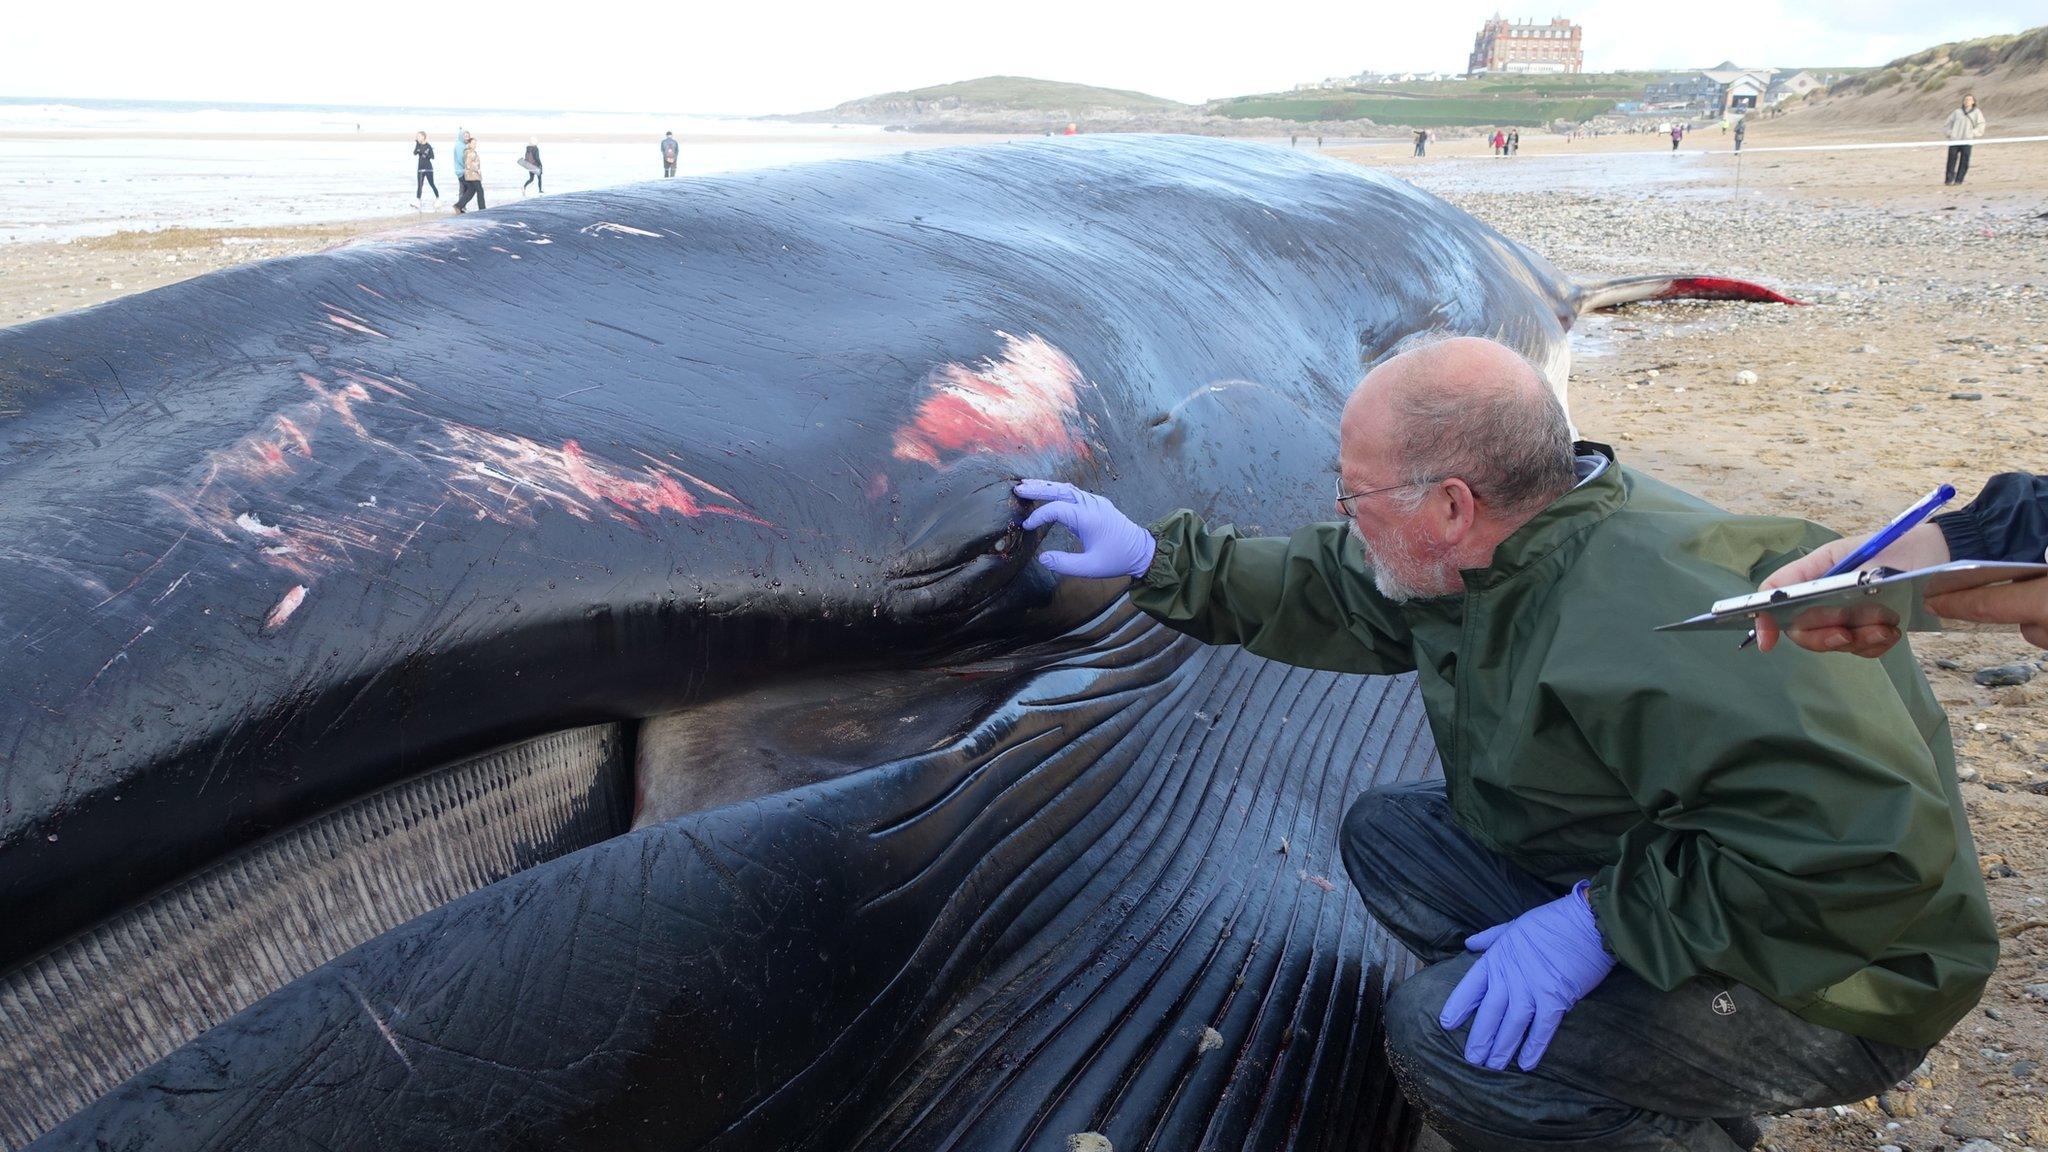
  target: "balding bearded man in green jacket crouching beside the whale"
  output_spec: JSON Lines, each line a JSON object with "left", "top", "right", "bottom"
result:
{"left": 1018, "top": 338, "right": 1999, "bottom": 1152}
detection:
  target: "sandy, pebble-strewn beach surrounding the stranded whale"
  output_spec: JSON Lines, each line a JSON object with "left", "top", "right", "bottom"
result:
{"left": 0, "top": 117, "right": 2048, "bottom": 1152}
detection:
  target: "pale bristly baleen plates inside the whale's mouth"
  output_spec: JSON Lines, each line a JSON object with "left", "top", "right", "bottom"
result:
{"left": 0, "top": 724, "right": 633, "bottom": 1150}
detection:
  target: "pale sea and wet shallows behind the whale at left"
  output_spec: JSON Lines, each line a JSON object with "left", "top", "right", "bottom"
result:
{"left": 0, "top": 96, "right": 987, "bottom": 242}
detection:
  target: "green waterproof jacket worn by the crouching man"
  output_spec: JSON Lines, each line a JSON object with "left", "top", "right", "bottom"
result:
{"left": 1130, "top": 445, "right": 1999, "bottom": 1047}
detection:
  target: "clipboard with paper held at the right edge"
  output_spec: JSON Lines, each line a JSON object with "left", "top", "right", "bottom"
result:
{"left": 1657, "top": 560, "right": 2048, "bottom": 631}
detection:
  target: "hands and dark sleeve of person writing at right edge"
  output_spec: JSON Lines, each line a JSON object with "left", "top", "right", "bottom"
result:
{"left": 1757, "top": 471, "right": 2048, "bottom": 656}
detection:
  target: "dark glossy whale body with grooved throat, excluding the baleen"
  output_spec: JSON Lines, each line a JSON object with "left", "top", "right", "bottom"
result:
{"left": 0, "top": 137, "right": 1579, "bottom": 1148}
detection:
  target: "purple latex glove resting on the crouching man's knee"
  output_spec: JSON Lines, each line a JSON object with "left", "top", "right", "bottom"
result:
{"left": 1438, "top": 879, "right": 1614, "bottom": 1072}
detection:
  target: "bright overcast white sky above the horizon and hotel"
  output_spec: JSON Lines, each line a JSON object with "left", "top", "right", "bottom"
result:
{"left": 0, "top": 0, "right": 2048, "bottom": 113}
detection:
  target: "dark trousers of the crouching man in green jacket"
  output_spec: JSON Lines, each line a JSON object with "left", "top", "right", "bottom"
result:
{"left": 1341, "top": 781, "right": 1925, "bottom": 1152}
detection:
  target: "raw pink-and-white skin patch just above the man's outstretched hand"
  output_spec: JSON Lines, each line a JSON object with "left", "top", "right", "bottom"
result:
{"left": 895, "top": 332, "right": 1090, "bottom": 467}
